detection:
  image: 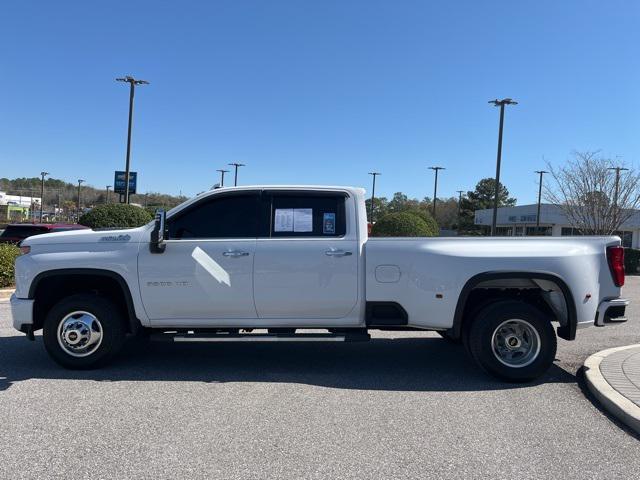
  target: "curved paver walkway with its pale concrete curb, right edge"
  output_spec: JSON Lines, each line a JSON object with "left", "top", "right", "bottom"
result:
{"left": 584, "top": 344, "right": 640, "bottom": 433}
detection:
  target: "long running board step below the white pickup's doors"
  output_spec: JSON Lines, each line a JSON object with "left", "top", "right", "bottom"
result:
{"left": 151, "top": 333, "right": 371, "bottom": 343}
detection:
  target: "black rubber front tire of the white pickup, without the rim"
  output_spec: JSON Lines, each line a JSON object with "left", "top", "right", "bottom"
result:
{"left": 42, "top": 294, "right": 125, "bottom": 370}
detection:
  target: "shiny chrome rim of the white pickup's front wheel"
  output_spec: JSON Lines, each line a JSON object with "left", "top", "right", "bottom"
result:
{"left": 58, "top": 311, "right": 102, "bottom": 357}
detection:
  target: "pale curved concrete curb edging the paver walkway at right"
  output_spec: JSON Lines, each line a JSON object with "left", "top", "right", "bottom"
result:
{"left": 584, "top": 344, "right": 640, "bottom": 434}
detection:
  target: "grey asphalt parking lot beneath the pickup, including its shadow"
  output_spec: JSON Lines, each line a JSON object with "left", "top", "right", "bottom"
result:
{"left": 0, "top": 277, "right": 640, "bottom": 479}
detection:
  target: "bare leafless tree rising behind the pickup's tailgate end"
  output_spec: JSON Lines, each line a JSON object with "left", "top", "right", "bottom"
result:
{"left": 545, "top": 151, "right": 640, "bottom": 235}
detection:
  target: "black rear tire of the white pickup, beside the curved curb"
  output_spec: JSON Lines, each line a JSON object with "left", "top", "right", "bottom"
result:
{"left": 463, "top": 300, "right": 557, "bottom": 382}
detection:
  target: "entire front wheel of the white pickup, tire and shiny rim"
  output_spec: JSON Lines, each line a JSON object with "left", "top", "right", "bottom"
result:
{"left": 43, "top": 294, "right": 125, "bottom": 369}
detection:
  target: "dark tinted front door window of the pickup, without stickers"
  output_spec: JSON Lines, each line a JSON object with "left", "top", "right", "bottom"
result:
{"left": 167, "top": 193, "right": 259, "bottom": 240}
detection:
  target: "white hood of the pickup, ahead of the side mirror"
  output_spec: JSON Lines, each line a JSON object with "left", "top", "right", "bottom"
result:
{"left": 22, "top": 225, "right": 147, "bottom": 246}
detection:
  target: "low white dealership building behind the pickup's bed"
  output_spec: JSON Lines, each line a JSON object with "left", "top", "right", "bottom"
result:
{"left": 474, "top": 203, "right": 640, "bottom": 248}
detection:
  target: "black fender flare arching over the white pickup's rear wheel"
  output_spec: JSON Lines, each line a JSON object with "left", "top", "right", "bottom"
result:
{"left": 451, "top": 272, "right": 578, "bottom": 340}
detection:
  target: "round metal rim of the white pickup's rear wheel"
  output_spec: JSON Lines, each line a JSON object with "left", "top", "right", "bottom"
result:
{"left": 491, "top": 319, "right": 540, "bottom": 368}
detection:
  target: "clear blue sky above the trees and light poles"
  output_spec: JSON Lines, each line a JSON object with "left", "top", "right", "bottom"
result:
{"left": 0, "top": 0, "right": 640, "bottom": 203}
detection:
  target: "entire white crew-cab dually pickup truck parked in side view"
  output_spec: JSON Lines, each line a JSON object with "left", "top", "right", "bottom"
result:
{"left": 11, "top": 186, "right": 628, "bottom": 381}
